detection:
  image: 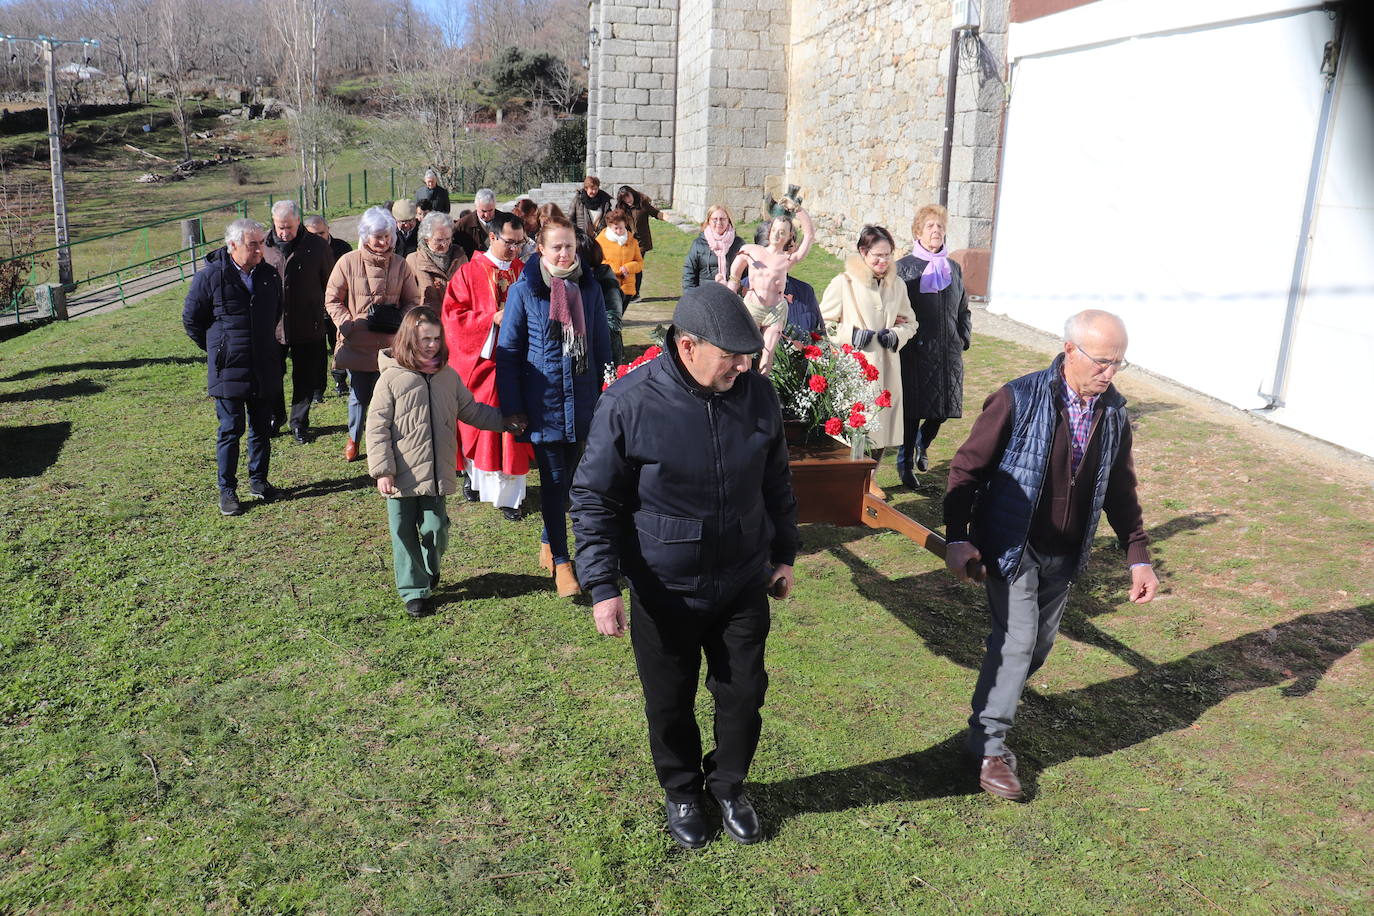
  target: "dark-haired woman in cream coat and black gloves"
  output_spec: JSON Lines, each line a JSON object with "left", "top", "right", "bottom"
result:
{"left": 820, "top": 225, "right": 916, "bottom": 461}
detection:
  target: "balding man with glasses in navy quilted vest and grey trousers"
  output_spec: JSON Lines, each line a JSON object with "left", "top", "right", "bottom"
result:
{"left": 944, "top": 310, "right": 1160, "bottom": 801}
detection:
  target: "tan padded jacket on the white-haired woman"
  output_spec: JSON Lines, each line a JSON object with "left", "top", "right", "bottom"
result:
{"left": 324, "top": 249, "right": 420, "bottom": 372}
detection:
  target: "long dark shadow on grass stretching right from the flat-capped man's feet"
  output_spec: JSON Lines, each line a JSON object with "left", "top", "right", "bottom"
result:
{"left": 750, "top": 604, "right": 1374, "bottom": 821}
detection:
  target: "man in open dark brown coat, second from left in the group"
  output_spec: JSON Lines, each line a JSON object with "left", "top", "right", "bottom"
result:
{"left": 262, "top": 201, "right": 334, "bottom": 444}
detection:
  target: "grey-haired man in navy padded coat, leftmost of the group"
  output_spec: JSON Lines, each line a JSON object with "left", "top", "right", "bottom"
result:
{"left": 181, "top": 220, "right": 282, "bottom": 515}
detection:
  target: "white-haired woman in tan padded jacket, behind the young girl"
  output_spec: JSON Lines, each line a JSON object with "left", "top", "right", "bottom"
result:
{"left": 324, "top": 207, "right": 420, "bottom": 461}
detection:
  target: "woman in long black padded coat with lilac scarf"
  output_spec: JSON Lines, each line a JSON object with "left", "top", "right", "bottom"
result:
{"left": 897, "top": 203, "right": 973, "bottom": 488}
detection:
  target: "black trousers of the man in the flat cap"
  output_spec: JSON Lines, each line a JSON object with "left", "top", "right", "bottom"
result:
{"left": 629, "top": 584, "right": 769, "bottom": 802}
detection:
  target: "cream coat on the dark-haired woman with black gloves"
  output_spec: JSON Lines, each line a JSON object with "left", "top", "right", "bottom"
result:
{"left": 820, "top": 254, "right": 916, "bottom": 449}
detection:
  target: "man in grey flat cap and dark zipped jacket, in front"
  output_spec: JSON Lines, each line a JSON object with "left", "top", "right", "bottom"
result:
{"left": 572, "top": 283, "right": 798, "bottom": 849}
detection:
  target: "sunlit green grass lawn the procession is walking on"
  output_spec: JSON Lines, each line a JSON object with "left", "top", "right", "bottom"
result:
{"left": 0, "top": 224, "right": 1374, "bottom": 915}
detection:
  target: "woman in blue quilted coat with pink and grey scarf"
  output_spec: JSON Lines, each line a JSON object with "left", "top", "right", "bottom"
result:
{"left": 496, "top": 217, "right": 611, "bottom": 597}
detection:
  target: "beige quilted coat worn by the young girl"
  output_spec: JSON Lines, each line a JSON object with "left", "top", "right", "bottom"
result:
{"left": 367, "top": 349, "right": 504, "bottom": 496}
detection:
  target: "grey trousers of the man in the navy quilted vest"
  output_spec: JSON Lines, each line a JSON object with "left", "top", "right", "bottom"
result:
{"left": 969, "top": 544, "right": 1077, "bottom": 757}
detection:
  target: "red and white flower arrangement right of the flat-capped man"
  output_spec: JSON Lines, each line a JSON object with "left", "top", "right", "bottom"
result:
{"left": 769, "top": 328, "right": 892, "bottom": 455}
